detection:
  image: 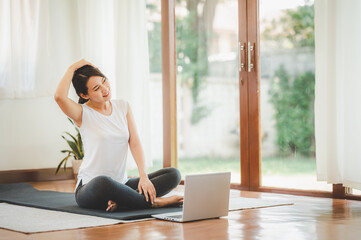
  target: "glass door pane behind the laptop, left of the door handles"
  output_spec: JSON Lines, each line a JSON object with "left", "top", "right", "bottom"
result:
{"left": 176, "top": 0, "right": 240, "bottom": 183}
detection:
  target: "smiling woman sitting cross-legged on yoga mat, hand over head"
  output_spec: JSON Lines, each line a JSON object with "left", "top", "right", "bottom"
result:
{"left": 54, "top": 60, "right": 183, "bottom": 211}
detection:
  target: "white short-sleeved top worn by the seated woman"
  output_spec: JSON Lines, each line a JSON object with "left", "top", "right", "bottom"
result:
{"left": 75, "top": 100, "right": 129, "bottom": 189}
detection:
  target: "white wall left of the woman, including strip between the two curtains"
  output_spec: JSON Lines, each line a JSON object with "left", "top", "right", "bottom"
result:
{"left": 0, "top": 0, "right": 81, "bottom": 171}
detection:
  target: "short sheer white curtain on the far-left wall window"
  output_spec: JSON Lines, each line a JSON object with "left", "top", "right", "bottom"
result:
{"left": 0, "top": 0, "right": 51, "bottom": 99}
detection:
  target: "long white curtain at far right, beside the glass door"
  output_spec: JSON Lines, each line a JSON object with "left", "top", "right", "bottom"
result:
{"left": 315, "top": 0, "right": 361, "bottom": 189}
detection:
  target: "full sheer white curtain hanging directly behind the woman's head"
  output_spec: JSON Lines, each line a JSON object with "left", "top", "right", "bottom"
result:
{"left": 77, "top": 0, "right": 152, "bottom": 167}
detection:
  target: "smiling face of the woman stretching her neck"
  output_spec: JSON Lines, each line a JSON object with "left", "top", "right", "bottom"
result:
{"left": 82, "top": 76, "right": 111, "bottom": 102}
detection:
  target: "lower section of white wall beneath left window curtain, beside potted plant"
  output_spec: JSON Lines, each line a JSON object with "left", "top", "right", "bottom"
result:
{"left": 0, "top": 97, "right": 74, "bottom": 170}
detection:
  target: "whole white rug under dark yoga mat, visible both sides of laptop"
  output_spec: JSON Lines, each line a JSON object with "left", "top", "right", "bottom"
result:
{"left": 0, "top": 196, "right": 293, "bottom": 233}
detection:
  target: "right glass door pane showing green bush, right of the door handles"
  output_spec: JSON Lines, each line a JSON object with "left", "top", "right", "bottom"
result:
{"left": 260, "top": 0, "right": 332, "bottom": 191}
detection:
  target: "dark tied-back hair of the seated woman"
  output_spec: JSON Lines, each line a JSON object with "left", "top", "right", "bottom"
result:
{"left": 72, "top": 65, "right": 105, "bottom": 104}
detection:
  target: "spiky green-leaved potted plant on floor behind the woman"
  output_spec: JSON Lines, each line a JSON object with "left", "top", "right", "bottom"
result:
{"left": 55, "top": 118, "right": 84, "bottom": 181}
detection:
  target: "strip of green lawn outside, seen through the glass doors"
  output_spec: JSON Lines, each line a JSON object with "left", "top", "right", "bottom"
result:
{"left": 128, "top": 157, "right": 316, "bottom": 176}
